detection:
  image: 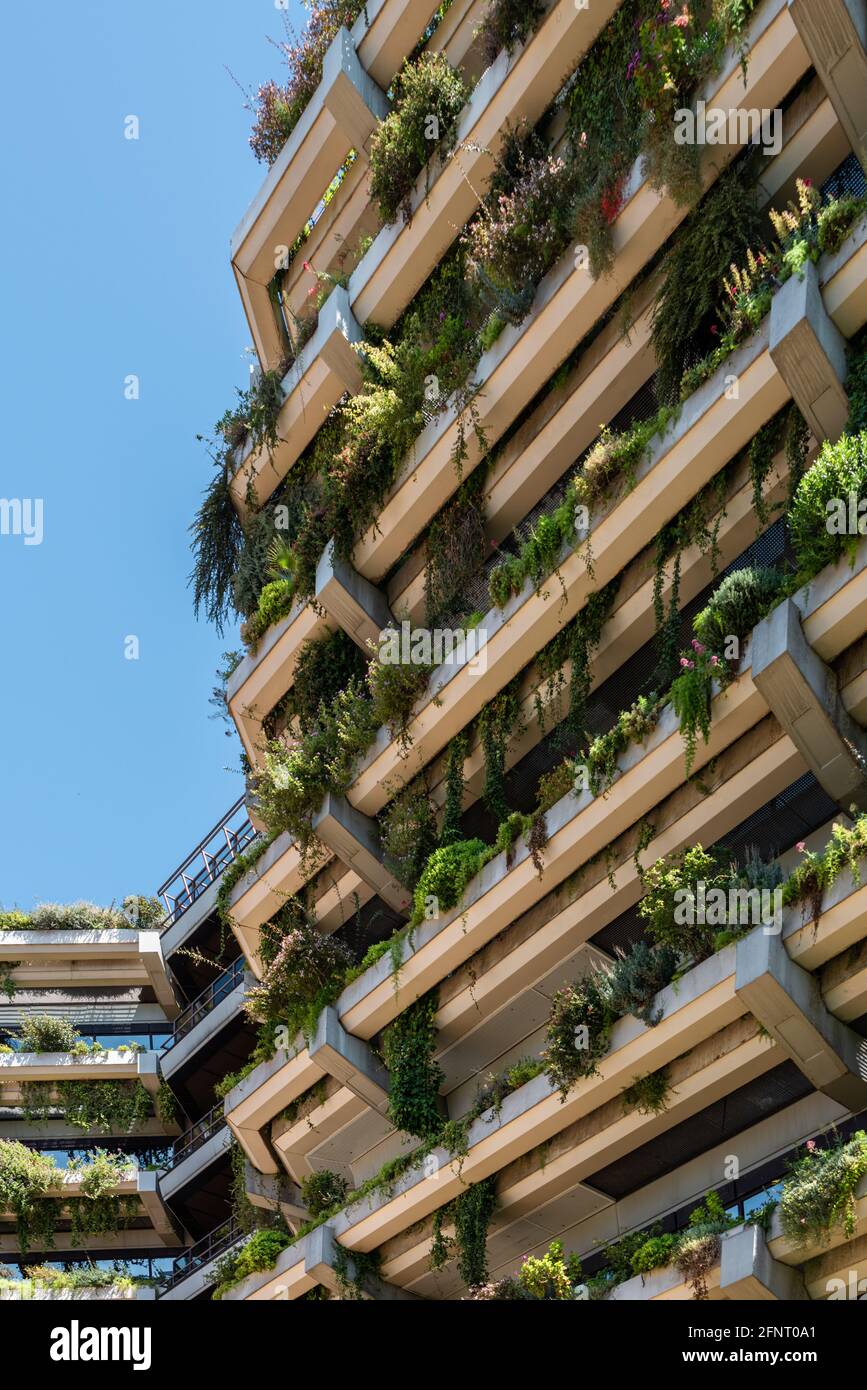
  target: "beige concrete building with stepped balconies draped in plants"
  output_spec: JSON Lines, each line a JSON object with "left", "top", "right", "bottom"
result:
{"left": 0, "top": 0, "right": 867, "bottom": 1301}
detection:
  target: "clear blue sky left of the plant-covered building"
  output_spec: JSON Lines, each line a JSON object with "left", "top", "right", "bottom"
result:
{"left": 0, "top": 0, "right": 302, "bottom": 909}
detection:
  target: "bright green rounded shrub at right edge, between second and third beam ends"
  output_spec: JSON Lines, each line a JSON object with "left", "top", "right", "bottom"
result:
{"left": 789, "top": 431, "right": 867, "bottom": 578}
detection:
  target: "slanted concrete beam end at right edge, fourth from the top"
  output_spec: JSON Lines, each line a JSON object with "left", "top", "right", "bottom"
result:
{"left": 735, "top": 927, "right": 867, "bottom": 1112}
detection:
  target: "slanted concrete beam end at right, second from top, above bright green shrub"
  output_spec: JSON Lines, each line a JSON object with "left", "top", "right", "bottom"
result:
{"left": 768, "top": 261, "right": 849, "bottom": 441}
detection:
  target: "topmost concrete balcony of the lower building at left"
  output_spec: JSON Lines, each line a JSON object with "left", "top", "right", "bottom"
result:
{"left": 0, "top": 927, "right": 179, "bottom": 1019}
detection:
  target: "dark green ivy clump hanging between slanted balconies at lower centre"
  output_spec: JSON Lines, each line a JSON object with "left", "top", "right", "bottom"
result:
{"left": 382, "top": 991, "right": 445, "bottom": 1138}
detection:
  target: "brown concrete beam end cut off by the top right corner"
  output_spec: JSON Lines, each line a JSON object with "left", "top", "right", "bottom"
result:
{"left": 789, "top": 0, "right": 867, "bottom": 167}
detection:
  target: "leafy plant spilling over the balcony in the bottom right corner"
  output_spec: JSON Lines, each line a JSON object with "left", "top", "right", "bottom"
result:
{"left": 779, "top": 1130, "right": 867, "bottom": 1245}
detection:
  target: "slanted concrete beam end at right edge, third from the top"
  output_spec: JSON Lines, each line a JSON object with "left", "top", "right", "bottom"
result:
{"left": 752, "top": 599, "right": 867, "bottom": 810}
